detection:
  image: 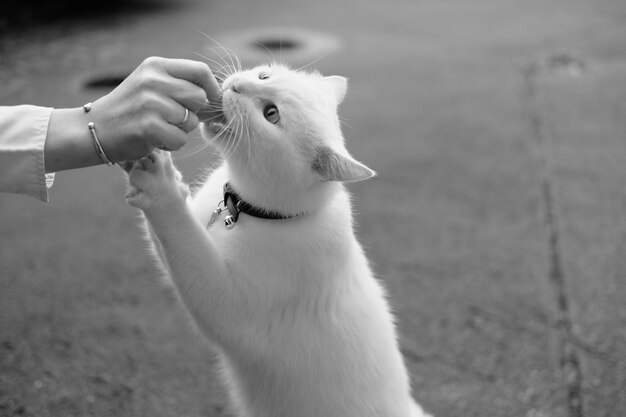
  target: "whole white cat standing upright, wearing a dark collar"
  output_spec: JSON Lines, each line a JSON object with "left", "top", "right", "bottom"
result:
{"left": 127, "top": 65, "right": 432, "bottom": 417}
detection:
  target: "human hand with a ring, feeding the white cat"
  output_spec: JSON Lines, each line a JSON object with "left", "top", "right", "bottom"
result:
{"left": 89, "top": 57, "right": 221, "bottom": 162}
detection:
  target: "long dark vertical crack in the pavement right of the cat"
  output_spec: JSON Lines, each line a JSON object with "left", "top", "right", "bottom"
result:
{"left": 522, "top": 62, "right": 585, "bottom": 417}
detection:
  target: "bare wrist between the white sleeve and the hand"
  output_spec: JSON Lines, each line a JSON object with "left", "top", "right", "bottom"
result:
{"left": 44, "top": 107, "right": 106, "bottom": 172}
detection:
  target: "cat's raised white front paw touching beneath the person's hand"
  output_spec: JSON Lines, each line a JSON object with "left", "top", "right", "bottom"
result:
{"left": 122, "top": 150, "right": 189, "bottom": 211}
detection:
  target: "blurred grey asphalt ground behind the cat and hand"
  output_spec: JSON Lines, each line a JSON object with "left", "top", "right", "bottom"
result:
{"left": 0, "top": 0, "right": 626, "bottom": 417}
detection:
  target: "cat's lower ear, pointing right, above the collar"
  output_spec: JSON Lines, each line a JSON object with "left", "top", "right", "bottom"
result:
{"left": 313, "top": 146, "right": 376, "bottom": 182}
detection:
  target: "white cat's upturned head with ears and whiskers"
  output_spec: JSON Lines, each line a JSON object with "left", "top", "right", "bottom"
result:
{"left": 205, "top": 65, "right": 375, "bottom": 193}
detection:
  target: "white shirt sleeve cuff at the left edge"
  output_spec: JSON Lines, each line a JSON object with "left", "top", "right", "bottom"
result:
{"left": 0, "top": 105, "right": 54, "bottom": 202}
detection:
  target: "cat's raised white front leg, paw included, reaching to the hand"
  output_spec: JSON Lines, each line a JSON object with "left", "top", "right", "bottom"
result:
{"left": 125, "top": 152, "right": 230, "bottom": 340}
